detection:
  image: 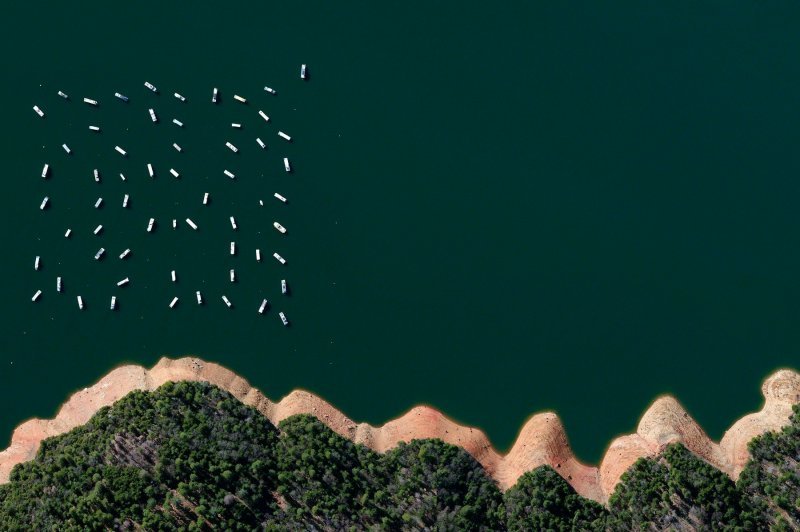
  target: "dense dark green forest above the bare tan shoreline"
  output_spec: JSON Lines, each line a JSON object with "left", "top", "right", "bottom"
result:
{"left": 0, "top": 382, "right": 800, "bottom": 531}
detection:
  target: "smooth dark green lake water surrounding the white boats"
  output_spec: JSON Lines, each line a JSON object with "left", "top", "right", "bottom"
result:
{"left": 0, "top": 1, "right": 800, "bottom": 461}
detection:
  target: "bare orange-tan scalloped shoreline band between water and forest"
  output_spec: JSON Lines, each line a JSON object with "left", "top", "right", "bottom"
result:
{"left": 0, "top": 357, "right": 800, "bottom": 503}
